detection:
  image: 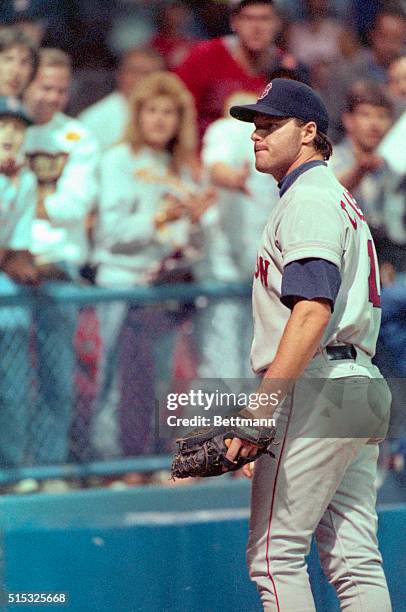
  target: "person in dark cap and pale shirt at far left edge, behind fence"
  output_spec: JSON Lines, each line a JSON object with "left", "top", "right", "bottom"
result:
{"left": 0, "top": 96, "right": 37, "bottom": 468}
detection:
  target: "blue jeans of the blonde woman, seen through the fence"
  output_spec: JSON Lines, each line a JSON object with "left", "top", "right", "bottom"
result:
{"left": 91, "top": 301, "right": 183, "bottom": 458}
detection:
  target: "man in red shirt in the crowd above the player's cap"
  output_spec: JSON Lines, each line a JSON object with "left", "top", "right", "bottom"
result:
{"left": 176, "top": 0, "right": 304, "bottom": 136}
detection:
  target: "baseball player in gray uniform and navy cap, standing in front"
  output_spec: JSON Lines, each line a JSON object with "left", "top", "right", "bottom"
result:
{"left": 222, "top": 79, "right": 391, "bottom": 612}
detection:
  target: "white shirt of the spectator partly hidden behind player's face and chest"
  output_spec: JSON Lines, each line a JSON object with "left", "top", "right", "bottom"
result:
{"left": 202, "top": 118, "right": 279, "bottom": 279}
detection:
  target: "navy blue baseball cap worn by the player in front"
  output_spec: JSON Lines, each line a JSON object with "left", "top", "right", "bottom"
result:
{"left": 230, "top": 79, "right": 329, "bottom": 134}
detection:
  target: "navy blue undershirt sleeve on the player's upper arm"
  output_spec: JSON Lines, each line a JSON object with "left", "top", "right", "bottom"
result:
{"left": 281, "top": 258, "right": 341, "bottom": 310}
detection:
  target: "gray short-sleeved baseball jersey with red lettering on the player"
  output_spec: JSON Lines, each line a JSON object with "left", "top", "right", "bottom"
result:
{"left": 251, "top": 163, "right": 381, "bottom": 377}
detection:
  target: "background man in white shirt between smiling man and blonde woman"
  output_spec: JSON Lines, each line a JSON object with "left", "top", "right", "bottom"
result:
{"left": 79, "top": 48, "right": 164, "bottom": 151}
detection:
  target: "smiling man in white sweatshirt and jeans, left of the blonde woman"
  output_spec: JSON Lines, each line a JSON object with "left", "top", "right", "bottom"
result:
{"left": 24, "top": 48, "right": 98, "bottom": 462}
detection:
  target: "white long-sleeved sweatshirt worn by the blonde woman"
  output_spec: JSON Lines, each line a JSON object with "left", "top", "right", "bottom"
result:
{"left": 92, "top": 144, "right": 235, "bottom": 286}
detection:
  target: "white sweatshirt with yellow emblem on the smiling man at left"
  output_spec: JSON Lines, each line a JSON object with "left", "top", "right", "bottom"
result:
{"left": 24, "top": 113, "right": 99, "bottom": 265}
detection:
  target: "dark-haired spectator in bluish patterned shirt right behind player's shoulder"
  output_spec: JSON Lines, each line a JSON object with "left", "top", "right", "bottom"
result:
{"left": 330, "top": 81, "right": 406, "bottom": 267}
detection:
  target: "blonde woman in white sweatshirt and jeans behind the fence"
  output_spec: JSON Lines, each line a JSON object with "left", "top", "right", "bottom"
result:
{"left": 89, "top": 72, "right": 235, "bottom": 455}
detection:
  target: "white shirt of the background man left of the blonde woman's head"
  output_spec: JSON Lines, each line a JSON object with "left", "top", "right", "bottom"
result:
{"left": 78, "top": 91, "right": 130, "bottom": 151}
